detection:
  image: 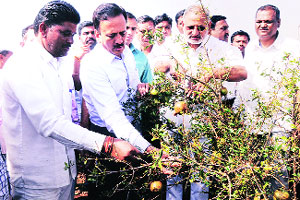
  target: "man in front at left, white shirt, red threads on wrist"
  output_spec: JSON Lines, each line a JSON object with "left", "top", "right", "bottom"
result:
{"left": 2, "top": 1, "right": 137, "bottom": 200}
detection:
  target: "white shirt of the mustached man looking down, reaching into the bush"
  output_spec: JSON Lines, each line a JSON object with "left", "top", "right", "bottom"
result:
{"left": 80, "top": 45, "right": 150, "bottom": 151}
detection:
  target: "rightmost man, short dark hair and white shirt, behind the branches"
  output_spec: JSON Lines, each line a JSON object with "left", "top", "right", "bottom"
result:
{"left": 240, "top": 5, "right": 300, "bottom": 132}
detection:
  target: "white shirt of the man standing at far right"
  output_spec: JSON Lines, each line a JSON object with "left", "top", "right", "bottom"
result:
{"left": 238, "top": 34, "right": 300, "bottom": 131}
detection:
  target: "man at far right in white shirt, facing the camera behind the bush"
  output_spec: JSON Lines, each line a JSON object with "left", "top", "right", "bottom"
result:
{"left": 238, "top": 5, "right": 300, "bottom": 197}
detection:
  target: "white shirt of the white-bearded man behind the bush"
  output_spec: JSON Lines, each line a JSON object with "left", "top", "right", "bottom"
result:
{"left": 170, "top": 35, "right": 244, "bottom": 98}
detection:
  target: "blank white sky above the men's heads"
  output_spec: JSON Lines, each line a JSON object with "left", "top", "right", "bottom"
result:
{"left": 0, "top": 0, "right": 300, "bottom": 50}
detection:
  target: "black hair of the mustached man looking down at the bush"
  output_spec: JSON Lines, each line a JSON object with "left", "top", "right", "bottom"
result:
{"left": 93, "top": 3, "right": 127, "bottom": 30}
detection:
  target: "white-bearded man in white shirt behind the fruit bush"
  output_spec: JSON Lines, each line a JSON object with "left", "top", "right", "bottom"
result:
{"left": 158, "top": 5, "right": 247, "bottom": 104}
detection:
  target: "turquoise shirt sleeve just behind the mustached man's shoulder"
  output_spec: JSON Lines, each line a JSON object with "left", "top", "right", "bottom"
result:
{"left": 129, "top": 44, "right": 153, "bottom": 83}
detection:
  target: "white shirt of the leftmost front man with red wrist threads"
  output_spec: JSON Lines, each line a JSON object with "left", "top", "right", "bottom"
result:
{"left": 1, "top": 42, "right": 105, "bottom": 189}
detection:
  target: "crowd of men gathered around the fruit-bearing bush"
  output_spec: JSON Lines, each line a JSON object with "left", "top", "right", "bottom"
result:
{"left": 0, "top": 1, "right": 300, "bottom": 200}
